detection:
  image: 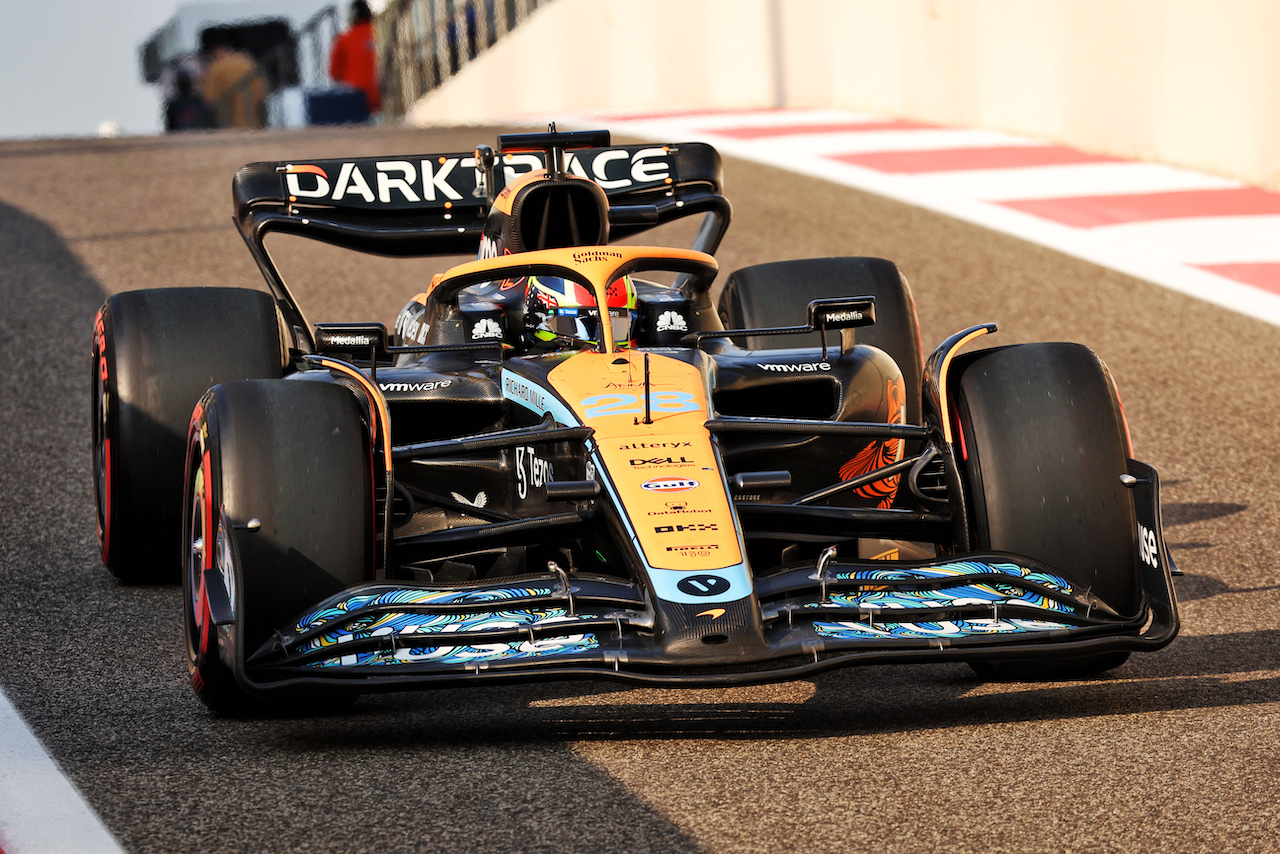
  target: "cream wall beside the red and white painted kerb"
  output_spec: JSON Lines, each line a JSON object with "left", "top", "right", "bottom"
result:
{"left": 406, "top": 0, "right": 1280, "bottom": 189}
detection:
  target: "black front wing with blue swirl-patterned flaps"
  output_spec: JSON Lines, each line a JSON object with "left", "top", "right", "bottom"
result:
{"left": 234, "top": 461, "right": 1178, "bottom": 693}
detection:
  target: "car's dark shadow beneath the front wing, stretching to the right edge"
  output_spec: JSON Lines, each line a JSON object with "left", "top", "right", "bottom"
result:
{"left": 270, "top": 631, "right": 1280, "bottom": 748}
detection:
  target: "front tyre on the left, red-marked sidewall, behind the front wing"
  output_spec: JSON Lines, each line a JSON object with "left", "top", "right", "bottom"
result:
{"left": 182, "top": 380, "right": 374, "bottom": 714}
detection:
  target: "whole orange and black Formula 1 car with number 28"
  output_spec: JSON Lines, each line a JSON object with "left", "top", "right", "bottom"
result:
{"left": 92, "top": 129, "right": 1178, "bottom": 711}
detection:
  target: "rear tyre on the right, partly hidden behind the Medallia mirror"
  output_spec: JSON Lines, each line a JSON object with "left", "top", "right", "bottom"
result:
{"left": 718, "top": 257, "right": 923, "bottom": 424}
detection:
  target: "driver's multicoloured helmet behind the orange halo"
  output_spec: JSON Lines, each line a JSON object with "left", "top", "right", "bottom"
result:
{"left": 525, "top": 275, "right": 636, "bottom": 351}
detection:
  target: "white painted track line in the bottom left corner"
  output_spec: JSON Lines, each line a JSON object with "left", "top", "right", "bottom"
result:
{"left": 0, "top": 693, "right": 124, "bottom": 854}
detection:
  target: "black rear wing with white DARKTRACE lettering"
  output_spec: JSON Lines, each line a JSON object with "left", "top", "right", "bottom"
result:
{"left": 232, "top": 131, "right": 731, "bottom": 352}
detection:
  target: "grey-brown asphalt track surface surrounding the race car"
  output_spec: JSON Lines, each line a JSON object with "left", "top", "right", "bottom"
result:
{"left": 0, "top": 128, "right": 1280, "bottom": 851}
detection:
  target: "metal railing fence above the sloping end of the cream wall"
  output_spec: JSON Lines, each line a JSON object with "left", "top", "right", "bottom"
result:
{"left": 375, "top": 0, "right": 552, "bottom": 119}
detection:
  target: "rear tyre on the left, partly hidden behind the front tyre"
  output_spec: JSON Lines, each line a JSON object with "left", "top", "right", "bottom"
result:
{"left": 92, "top": 288, "right": 283, "bottom": 584}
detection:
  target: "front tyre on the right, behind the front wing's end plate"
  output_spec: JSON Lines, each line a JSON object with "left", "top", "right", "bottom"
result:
{"left": 948, "top": 343, "right": 1142, "bottom": 677}
